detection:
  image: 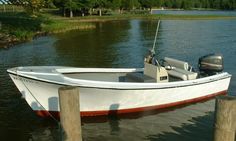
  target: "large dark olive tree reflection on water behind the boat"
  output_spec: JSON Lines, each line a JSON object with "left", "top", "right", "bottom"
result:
{"left": 55, "top": 21, "right": 130, "bottom": 67}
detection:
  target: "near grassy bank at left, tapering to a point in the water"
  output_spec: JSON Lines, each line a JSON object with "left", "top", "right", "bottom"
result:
{"left": 0, "top": 12, "right": 95, "bottom": 47}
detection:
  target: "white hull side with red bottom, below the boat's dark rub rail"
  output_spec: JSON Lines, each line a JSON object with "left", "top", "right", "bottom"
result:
{"left": 10, "top": 73, "right": 230, "bottom": 117}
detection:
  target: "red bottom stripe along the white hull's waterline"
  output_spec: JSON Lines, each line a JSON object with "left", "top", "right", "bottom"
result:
{"left": 35, "top": 90, "right": 227, "bottom": 118}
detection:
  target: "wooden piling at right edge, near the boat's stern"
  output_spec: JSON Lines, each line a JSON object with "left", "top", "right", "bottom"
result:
{"left": 214, "top": 96, "right": 236, "bottom": 141}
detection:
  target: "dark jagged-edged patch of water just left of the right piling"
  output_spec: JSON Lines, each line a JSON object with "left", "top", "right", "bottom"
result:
{"left": 146, "top": 112, "right": 214, "bottom": 141}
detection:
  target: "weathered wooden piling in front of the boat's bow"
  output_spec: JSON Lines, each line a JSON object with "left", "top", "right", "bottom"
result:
{"left": 59, "top": 87, "right": 82, "bottom": 141}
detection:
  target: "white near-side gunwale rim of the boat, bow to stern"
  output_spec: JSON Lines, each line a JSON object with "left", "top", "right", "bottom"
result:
{"left": 7, "top": 68, "right": 232, "bottom": 90}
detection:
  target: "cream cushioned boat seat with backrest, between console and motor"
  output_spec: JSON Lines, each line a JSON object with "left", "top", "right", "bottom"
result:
{"left": 164, "top": 57, "right": 198, "bottom": 80}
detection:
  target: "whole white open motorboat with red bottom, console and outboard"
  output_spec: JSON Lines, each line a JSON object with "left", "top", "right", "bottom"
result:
{"left": 7, "top": 55, "right": 231, "bottom": 117}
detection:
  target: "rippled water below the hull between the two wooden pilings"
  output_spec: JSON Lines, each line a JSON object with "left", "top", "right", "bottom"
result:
{"left": 82, "top": 100, "right": 214, "bottom": 141}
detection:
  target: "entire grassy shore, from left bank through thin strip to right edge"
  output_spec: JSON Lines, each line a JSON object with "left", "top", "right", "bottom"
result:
{"left": 0, "top": 12, "right": 236, "bottom": 47}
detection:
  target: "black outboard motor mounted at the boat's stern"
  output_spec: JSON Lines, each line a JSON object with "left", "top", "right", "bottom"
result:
{"left": 198, "top": 54, "right": 224, "bottom": 75}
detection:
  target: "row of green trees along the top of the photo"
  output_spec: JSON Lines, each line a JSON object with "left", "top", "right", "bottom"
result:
{"left": 10, "top": 0, "right": 236, "bottom": 17}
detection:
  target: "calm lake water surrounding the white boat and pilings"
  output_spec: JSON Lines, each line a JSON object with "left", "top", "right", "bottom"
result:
{"left": 0, "top": 17, "right": 236, "bottom": 141}
